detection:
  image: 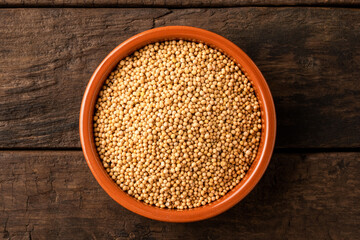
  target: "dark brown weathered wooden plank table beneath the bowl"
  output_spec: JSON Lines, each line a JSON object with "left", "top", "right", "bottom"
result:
{"left": 0, "top": 0, "right": 360, "bottom": 239}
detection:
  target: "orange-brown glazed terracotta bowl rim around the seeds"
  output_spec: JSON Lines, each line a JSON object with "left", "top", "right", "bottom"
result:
{"left": 80, "top": 26, "right": 276, "bottom": 222}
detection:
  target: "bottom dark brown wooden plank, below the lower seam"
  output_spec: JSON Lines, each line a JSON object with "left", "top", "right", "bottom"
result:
{"left": 0, "top": 151, "right": 360, "bottom": 239}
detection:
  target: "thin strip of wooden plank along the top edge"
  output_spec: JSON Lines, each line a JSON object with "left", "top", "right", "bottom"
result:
{"left": 0, "top": 0, "right": 360, "bottom": 8}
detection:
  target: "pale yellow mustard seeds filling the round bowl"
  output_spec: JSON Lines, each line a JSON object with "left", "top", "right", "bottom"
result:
{"left": 94, "top": 40, "right": 262, "bottom": 209}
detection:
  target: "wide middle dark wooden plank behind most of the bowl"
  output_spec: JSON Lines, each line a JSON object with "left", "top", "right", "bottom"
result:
{"left": 0, "top": 7, "right": 360, "bottom": 148}
